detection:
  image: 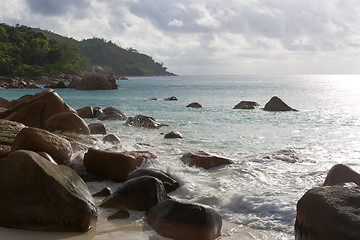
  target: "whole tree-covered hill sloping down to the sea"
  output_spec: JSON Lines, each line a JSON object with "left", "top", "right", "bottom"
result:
{"left": 0, "top": 23, "right": 174, "bottom": 77}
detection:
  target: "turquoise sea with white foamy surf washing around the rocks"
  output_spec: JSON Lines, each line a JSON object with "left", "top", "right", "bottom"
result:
{"left": 0, "top": 75, "right": 360, "bottom": 236}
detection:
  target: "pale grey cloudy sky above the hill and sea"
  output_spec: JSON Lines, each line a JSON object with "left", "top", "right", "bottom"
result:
{"left": 0, "top": 0, "right": 360, "bottom": 75}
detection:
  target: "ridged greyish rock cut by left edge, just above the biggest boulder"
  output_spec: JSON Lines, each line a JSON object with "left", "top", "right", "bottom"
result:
{"left": 0, "top": 119, "right": 25, "bottom": 158}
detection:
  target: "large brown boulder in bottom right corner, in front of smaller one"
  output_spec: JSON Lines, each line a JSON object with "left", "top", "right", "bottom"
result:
{"left": 295, "top": 185, "right": 360, "bottom": 240}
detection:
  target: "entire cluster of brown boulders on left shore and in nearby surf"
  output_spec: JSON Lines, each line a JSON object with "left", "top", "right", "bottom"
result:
{"left": 0, "top": 89, "right": 225, "bottom": 240}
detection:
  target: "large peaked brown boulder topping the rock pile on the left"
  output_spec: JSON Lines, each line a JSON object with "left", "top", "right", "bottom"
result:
{"left": 0, "top": 89, "right": 75, "bottom": 128}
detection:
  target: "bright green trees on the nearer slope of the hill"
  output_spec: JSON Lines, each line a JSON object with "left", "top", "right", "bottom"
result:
{"left": 0, "top": 23, "right": 86, "bottom": 77}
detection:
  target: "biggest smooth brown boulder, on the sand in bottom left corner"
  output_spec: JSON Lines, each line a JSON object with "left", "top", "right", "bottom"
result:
{"left": 0, "top": 150, "right": 97, "bottom": 232}
